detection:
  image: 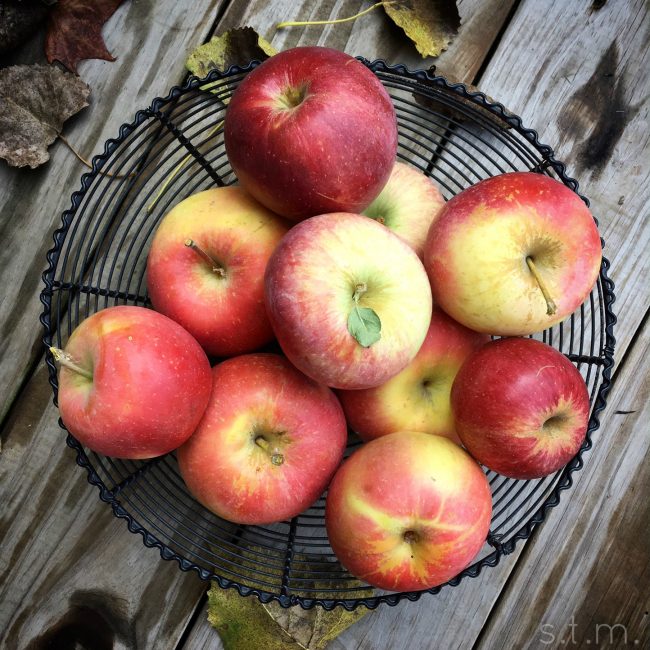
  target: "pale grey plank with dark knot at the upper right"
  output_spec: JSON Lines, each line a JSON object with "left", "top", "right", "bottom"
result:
{"left": 480, "top": 0, "right": 650, "bottom": 351}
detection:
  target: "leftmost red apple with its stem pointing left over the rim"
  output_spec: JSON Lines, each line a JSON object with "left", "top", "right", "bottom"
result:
{"left": 51, "top": 305, "right": 212, "bottom": 459}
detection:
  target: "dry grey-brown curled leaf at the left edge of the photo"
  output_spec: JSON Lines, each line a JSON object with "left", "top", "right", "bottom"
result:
{"left": 0, "top": 64, "right": 90, "bottom": 169}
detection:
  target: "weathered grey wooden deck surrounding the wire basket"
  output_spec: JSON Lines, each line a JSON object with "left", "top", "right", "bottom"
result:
{"left": 0, "top": 0, "right": 650, "bottom": 650}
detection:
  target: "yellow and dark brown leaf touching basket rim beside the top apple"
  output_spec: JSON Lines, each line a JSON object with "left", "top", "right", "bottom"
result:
{"left": 185, "top": 27, "right": 277, "bottom": 77}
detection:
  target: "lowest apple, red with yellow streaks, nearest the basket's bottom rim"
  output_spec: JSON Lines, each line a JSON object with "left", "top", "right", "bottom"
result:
{"left": 325, "top": 431, "right": 492, "bottom": 591}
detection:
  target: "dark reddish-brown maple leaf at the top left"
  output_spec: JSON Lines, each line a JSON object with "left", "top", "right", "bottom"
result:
{"left": 45, "top": 0, "right": 124, "bottom": 72}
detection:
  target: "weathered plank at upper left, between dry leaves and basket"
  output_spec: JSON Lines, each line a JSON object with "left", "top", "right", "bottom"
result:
{"left": 0, "top": 0, "right": 226, "bottom": 420}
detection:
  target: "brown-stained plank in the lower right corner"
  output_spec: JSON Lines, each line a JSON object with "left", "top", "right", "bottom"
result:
{"left": 478, "top": 324, "right": 650, "bottom": 648}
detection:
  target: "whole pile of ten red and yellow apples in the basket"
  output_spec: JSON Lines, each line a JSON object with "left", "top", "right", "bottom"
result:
{"left": 54, "top": 47, "right": 601, "bottom": 590}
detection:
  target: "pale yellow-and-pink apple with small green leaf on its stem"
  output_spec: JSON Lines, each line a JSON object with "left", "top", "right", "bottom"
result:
{"left": 264, "top": 212, "right": 431, "bottom": 389}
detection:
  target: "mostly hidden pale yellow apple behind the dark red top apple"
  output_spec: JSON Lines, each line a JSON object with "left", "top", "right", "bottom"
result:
{"left": 363, "top": 162, "right": 445, "bottom": 259}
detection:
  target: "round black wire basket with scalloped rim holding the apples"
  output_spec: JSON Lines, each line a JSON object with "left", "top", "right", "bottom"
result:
{"left": 41, "top": 59, "right": 616, "bottom": 610}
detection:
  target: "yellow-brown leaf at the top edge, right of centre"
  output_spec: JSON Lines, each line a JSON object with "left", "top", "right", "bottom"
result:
{"left": 384, "top": 0, "right": 460, "bottom": 58}
